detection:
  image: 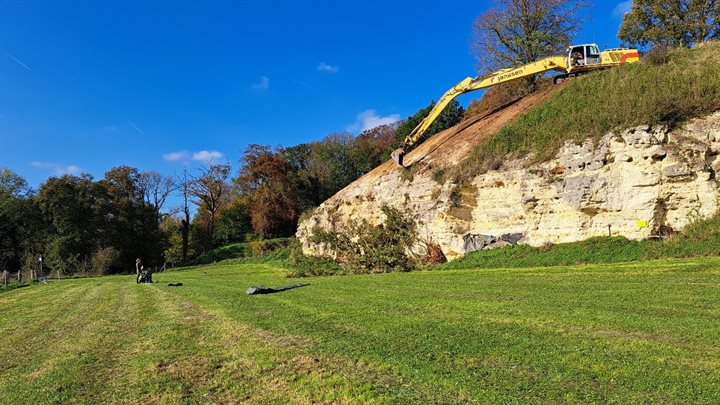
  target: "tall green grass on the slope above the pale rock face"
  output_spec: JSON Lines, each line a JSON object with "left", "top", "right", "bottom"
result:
{"left": 460, "top": 42, "right": 720, "bottom": 176}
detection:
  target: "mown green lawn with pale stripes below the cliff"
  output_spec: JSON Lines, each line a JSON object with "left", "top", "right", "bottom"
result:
{"left": 0, "top": 258, "right": 720, "bottom": 404}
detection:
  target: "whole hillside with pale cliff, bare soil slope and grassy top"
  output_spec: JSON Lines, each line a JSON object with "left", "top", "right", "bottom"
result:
{"left": 297, "top": 44, "right": 720, "bottom": 259}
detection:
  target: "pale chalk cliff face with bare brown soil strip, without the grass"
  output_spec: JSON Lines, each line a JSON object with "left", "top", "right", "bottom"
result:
{"left": 297, "top": 110, "right": 720, "bottom": 260}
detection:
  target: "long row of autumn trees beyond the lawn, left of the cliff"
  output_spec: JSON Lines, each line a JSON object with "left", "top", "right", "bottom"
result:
{"left": 0, "top": 103, "right": 463, "bottom": 275}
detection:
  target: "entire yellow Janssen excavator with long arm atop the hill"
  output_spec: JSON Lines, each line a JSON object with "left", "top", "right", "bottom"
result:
{"left": 391, "top": 44, "right": 640, "bottom": 166}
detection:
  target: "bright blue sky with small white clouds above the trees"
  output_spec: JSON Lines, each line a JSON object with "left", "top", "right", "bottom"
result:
{"left": 0, "top": 0, "right": 631, "bottom": 192}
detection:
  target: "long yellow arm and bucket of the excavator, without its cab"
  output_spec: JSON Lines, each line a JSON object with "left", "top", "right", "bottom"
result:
{"left": 391, "top": 56, "right": 570, "bottom": 166}
